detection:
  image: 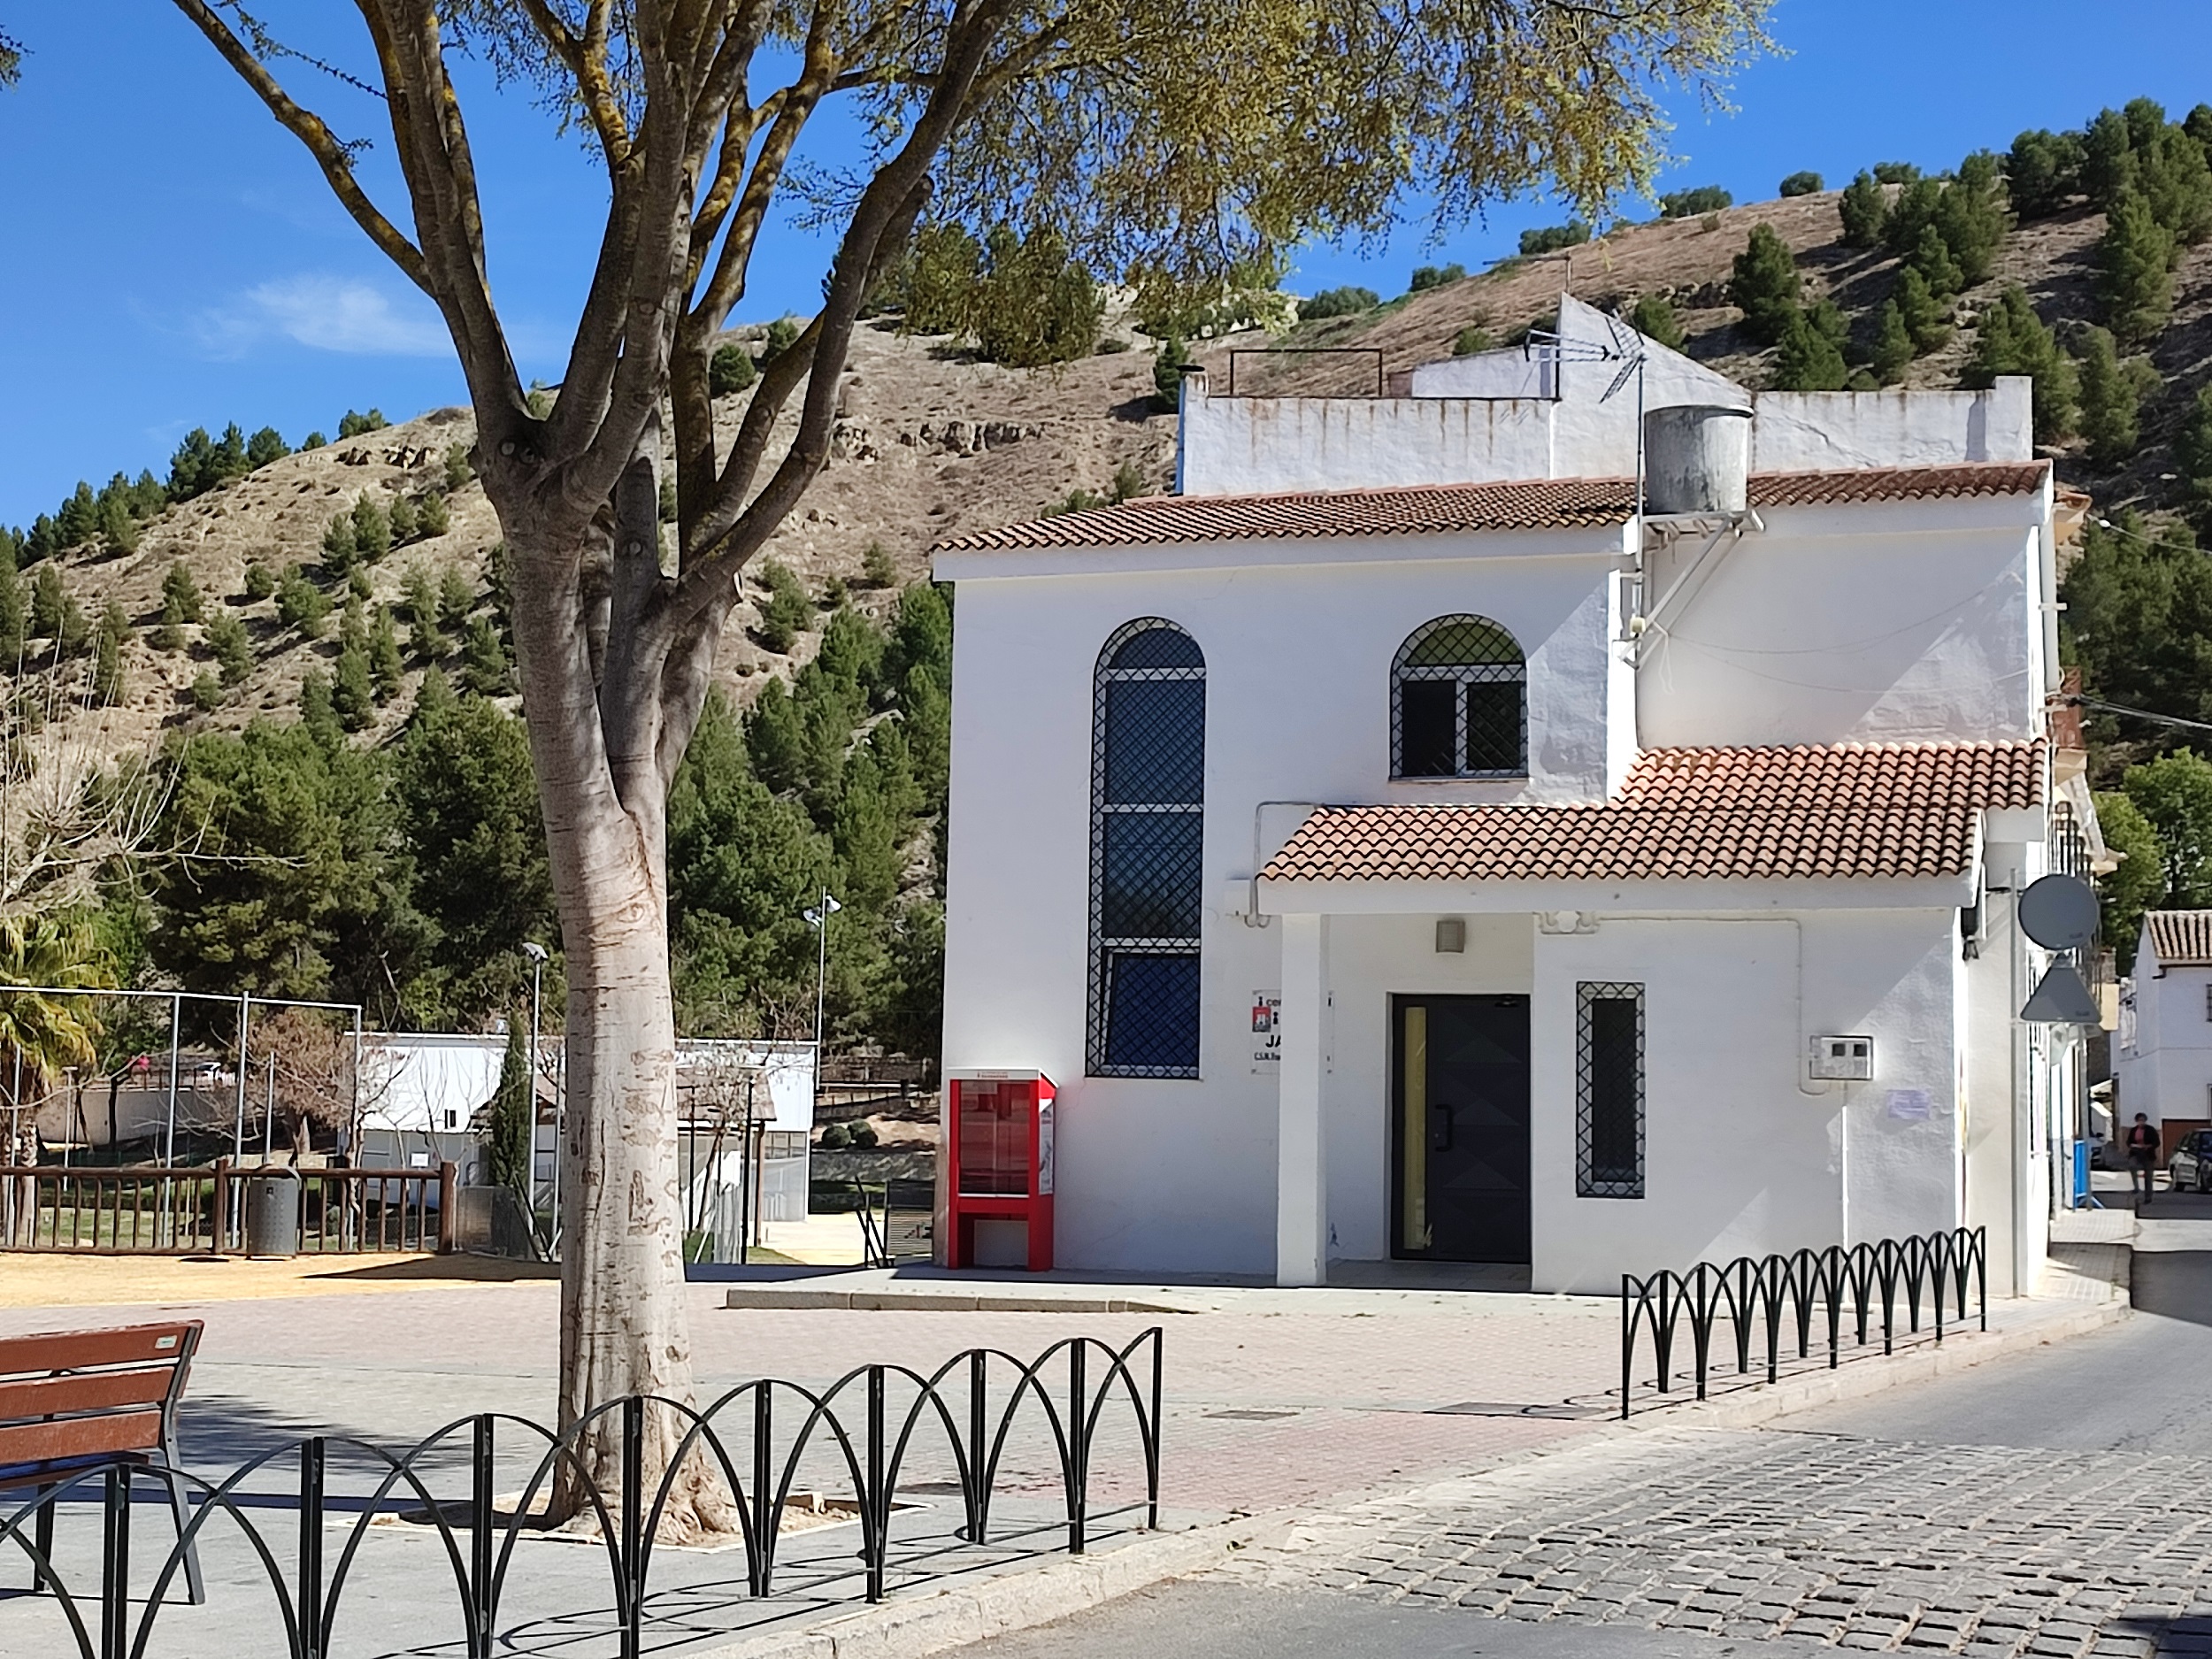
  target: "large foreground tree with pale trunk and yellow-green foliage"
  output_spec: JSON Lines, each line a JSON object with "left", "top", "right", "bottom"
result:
{"left": 175, "top": 0, "right": 1770, "bottom": 1522}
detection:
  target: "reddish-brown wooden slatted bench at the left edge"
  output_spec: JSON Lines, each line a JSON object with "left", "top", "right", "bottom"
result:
{"left": 0, "top": 1318, "right": 206, "bottom": 1604}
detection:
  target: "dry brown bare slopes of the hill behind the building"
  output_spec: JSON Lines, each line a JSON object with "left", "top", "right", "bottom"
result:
{"left": 30, "top": 177, "right": 2212, "bottom": 779}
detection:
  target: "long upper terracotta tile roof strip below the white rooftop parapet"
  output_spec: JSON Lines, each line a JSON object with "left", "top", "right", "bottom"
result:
{"left": 938, "top": 460, "right": 2051, "bottom": 551}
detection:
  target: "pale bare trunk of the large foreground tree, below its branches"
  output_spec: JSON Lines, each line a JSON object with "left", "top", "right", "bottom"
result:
{"left": 503, "top": 451, "right": 737, "bottom": 1538}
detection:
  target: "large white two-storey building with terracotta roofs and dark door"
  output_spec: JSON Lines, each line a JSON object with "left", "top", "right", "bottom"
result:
{"left": 936, "top": 301, "right": 2095, "bottom": 1294}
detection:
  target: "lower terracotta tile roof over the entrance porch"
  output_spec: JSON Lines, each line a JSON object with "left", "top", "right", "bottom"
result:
{"left": 1261, "top": 741, "right": 2044, "bottom": 883}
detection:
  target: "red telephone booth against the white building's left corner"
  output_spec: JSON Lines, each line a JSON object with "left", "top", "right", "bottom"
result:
{"left": 945, "top": 1071, "right": 1056, "bottom": 1274}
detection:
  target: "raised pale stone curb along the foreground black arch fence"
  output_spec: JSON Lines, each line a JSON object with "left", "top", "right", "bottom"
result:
{"left": 697, "top": 1511, "right": 1294, "bottom": 1659}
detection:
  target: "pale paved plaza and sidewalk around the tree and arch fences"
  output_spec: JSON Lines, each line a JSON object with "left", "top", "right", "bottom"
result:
{"left": 0, "top": 1256, "right": 2126, "bottom": 1659}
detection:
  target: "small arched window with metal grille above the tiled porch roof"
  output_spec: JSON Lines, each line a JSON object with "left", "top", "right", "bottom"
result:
{"left": 1389, "top": 618, "right": 1529, "bottom": 779}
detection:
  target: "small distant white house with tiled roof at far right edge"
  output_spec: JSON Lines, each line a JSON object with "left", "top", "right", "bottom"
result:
{"left": 2113, "top": 910, "right": 2212, "bottom": 1148}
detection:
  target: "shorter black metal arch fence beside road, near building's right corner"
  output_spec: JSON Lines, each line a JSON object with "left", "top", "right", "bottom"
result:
{"left": 1622, "top": 1228, "right": 1989, "bottom": 1418}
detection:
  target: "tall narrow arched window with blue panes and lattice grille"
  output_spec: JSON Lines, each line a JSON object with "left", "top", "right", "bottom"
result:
{"left": 1088, "top": 618, "right": 1206, "bottom": 1078}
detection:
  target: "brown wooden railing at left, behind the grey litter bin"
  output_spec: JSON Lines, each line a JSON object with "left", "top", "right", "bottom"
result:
{"left": 0, "top": 1162, "right": 460, "bottom": 1256}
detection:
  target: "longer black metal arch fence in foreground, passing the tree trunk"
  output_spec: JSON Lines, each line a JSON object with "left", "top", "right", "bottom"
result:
{"left": 0, "top": 1325, "right": 1162, "bottom": 1659}
